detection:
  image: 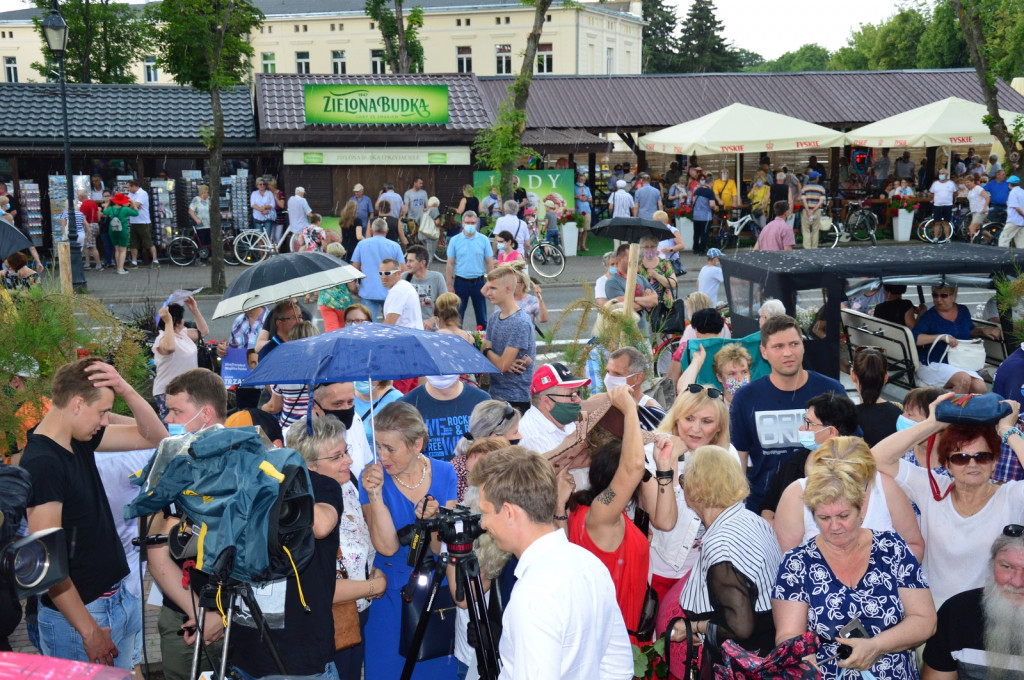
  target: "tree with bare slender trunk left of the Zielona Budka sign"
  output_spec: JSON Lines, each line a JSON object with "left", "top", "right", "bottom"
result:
{"left": 157, "top": 0, "right": 263, "bottom": 293}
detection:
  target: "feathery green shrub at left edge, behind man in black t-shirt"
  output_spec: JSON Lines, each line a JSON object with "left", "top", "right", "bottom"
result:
{"left": 0, "top": 286, "right": 148, "bottom": 448}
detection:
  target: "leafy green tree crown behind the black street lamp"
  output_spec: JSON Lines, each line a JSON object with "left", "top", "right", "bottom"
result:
{"left": 31, "top": 0, "right": 154, "bottom": 83}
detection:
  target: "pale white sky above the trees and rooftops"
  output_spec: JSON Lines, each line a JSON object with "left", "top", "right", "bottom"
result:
{"left": 0, "top": 0, "right": 898, "bottom": 59}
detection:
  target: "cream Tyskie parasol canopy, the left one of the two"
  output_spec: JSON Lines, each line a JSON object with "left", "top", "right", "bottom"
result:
{"left": 639, "top": 103, "right": 843, "bottom": 155}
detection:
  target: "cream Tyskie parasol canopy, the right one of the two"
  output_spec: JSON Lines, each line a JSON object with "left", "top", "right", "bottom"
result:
{"left": 846, "top": 97, "right": 1018, "bottom": 148}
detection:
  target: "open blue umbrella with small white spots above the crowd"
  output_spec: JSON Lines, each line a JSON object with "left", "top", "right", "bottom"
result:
{"left": 242, "top": 324, "right": 499, "bottom": 386}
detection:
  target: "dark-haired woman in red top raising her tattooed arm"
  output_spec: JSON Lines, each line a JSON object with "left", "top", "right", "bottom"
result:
{"left": 568, "top": 387, "right": 675, "bottom": 642}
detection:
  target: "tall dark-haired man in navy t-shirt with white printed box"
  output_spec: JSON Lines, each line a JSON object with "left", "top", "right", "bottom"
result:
{"left": 729, "top": 314, "right": 846, "bottom": 512}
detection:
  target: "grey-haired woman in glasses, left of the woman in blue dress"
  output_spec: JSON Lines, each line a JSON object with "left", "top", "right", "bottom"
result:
{"left": 288, "top": 416, "right": 387, "bottom": 680}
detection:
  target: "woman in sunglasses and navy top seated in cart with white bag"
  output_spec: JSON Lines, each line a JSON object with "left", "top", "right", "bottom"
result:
{"left": 913, "top": 286, "right": 1002, "bottom": 394}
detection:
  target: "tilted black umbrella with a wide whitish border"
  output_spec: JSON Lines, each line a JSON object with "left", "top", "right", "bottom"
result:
{"left": 213, "top": 252, "right": 364, "bottom": 318}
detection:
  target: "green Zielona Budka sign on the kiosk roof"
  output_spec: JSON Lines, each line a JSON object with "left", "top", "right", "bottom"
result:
{"left": 303, "top": 85, "right": 449, "bottom": 125}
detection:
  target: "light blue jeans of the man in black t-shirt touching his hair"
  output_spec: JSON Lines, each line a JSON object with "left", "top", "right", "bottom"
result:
{"left": 39, "top": 581, "right": 142, "bottom": 670}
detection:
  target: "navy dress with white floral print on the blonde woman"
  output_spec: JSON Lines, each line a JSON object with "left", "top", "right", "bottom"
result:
{"left": 772, "top": 532, "right": 928, "bottom": 680}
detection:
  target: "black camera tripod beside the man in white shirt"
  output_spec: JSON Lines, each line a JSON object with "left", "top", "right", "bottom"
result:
{"left": 401, "top": 542, "right": 501, "bottom": 680}
